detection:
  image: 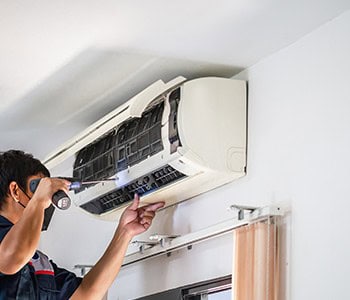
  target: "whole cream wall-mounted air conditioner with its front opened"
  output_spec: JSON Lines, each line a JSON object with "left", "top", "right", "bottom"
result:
{"left": 45, "top": 77, "right": 246, "bottom": 220}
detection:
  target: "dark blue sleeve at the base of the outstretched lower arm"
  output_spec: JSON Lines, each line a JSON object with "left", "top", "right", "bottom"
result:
{"left": 50, "top": 261, "right": 83, "bottom": 300}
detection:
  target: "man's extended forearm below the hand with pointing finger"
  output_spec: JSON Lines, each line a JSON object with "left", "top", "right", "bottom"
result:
{"left": 71, "top": 230, "right": 131, "bottom": 300}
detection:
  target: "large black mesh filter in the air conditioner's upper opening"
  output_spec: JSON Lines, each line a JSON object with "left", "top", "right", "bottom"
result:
{"left": 73, "top": 101, "right": 164, "bottom": 185}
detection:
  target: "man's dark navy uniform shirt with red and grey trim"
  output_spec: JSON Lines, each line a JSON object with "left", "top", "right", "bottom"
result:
{"left": 0, "top": 216, "right": 82, "bottom": 300}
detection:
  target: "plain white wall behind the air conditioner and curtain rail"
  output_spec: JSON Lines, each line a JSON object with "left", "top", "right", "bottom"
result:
{"left": 41, "top": 12, "right": 350, "bottom": 300}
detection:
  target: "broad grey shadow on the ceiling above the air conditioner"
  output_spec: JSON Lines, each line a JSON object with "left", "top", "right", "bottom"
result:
{"left": 0, "top": 48, "right": 241, "bottom": 157}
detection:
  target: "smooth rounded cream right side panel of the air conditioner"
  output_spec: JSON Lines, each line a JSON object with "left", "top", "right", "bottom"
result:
{"left": 178, "top": 77, "right": 246, "bottom": 173}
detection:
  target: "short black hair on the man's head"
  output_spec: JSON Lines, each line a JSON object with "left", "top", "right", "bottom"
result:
{"left": 0, "top": 150, "right": 50, "bottom": 208}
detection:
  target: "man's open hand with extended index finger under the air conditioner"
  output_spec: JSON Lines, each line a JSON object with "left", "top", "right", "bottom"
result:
{"left": 118, "top": 194, "right": 165, "bottom": 237}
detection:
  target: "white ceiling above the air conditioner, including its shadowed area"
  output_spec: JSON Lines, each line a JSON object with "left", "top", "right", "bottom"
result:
{"left": 0, "top": 0, "right": 350, "bottom": 158}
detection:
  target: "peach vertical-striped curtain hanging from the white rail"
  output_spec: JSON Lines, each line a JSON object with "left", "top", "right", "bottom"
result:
{"left": 232, "top": 218, "right": 279, "bottom": 300}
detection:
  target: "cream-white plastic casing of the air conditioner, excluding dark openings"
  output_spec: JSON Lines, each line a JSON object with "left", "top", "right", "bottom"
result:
{"left": 46, "top": 77, "right": 247, "bottom": 220}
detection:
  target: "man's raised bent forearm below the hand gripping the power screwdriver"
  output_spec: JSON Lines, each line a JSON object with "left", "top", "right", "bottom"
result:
{"left": 0, "top": 203, "right": 44, "bottom": 274}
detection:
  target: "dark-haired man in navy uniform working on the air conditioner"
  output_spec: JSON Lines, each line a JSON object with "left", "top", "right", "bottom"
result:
{"left": 0, "top": 150, "right": 164, "bottom": 300}
